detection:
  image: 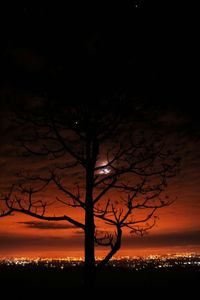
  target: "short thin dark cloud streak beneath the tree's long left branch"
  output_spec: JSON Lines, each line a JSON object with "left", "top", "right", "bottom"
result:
{"left": 18, "top": 221, "right": 74, "bottom": 230}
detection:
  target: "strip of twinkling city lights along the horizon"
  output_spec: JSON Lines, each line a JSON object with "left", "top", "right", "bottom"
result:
{"left": 0, "top": 253, "right": 200, "bottom": 271}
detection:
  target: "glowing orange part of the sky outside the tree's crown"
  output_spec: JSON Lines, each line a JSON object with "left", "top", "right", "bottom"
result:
{"left": 0, "top": 110, "right": 200, "bottom": 257}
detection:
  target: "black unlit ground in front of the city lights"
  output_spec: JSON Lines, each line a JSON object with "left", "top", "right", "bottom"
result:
{"left": 0, "top": 266, "right": 200, "bottom": 299}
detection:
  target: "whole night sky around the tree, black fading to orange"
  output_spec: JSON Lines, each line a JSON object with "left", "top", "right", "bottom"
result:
{"left": 0, "top": 1, "right": 200, "bottom": 256}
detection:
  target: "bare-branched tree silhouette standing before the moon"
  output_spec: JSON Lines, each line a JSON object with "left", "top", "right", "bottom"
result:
{"left": 1, "top": 97, "right": 179, "bottom": 286}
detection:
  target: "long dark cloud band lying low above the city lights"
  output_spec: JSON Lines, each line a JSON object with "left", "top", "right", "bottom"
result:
{"left": 0, "top": 230, "right": 200, "bottom": 254}
